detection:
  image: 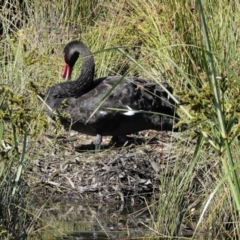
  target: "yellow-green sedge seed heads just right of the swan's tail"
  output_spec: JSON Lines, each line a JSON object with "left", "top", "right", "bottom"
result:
{"left": 179, "top": 77, "right": 240, "bottom": 144}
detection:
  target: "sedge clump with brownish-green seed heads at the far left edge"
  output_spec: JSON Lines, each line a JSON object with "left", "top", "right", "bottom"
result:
{"left": 0, "top": 87, "right": 47, "bottom": 239}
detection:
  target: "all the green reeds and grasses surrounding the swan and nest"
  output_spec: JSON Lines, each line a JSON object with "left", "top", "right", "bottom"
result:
{"left": 0, "top": 0, "right": 240, "bottom": 239}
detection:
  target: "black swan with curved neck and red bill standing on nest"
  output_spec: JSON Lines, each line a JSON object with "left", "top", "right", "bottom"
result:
{"left": 45, "top": 41, "right": 180, "bottom": 149}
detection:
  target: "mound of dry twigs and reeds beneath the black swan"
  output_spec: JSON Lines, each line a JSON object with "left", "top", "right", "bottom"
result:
{"left": 26, "top": 131, "right": 188, "bottom": 202}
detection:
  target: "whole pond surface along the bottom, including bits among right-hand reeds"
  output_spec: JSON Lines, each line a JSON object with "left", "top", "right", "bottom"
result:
{"left": 28, "top": 198, "right": 226, "bottom": 240}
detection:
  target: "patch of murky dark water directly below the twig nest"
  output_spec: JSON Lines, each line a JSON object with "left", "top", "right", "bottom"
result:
{"left": 34, "top": 202, "right": 150, "bottom": 240}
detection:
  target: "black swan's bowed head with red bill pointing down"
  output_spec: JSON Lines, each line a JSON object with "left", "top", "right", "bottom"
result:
{"left": 62, "top": 41, "right": 79, "bottom": 80}
